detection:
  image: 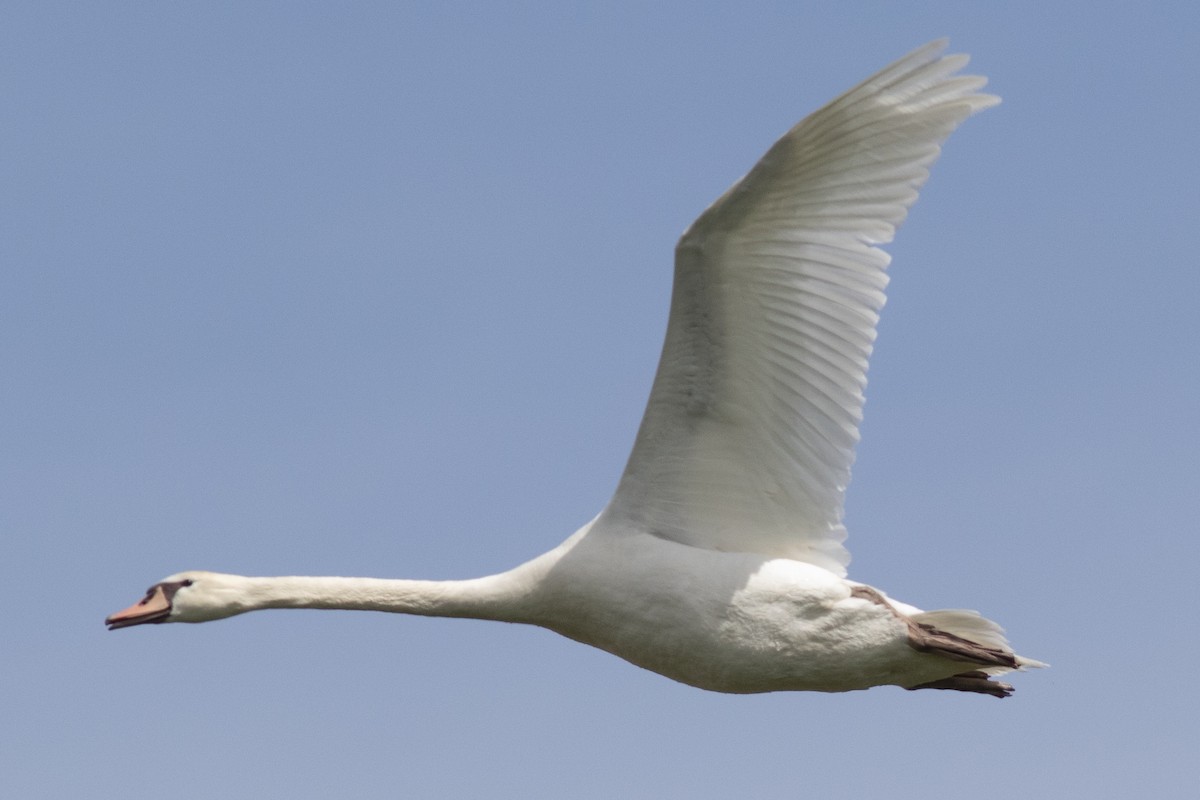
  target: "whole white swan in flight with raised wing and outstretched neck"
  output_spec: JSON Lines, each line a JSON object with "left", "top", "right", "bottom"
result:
{"left": 106, "top": 40, "right": 1044, "bottom": 697}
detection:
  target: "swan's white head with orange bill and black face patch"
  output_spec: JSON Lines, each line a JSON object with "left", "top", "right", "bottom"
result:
{"left": 104, "top": 572, "right": 250, "bottom": 631}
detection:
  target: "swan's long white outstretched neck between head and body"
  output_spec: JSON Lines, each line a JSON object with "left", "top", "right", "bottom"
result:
{"left": 228, "top": 573, "right": 529, "bottom": 621}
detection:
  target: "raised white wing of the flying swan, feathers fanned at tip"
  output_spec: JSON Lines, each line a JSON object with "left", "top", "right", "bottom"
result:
{"left": 605, "top": 41, "right": 998, "bottom": 575}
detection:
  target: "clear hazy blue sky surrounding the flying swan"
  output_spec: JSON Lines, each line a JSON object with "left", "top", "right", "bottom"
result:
{"left": 0, "top": 0, "right": 1200, "bottom": 800}
